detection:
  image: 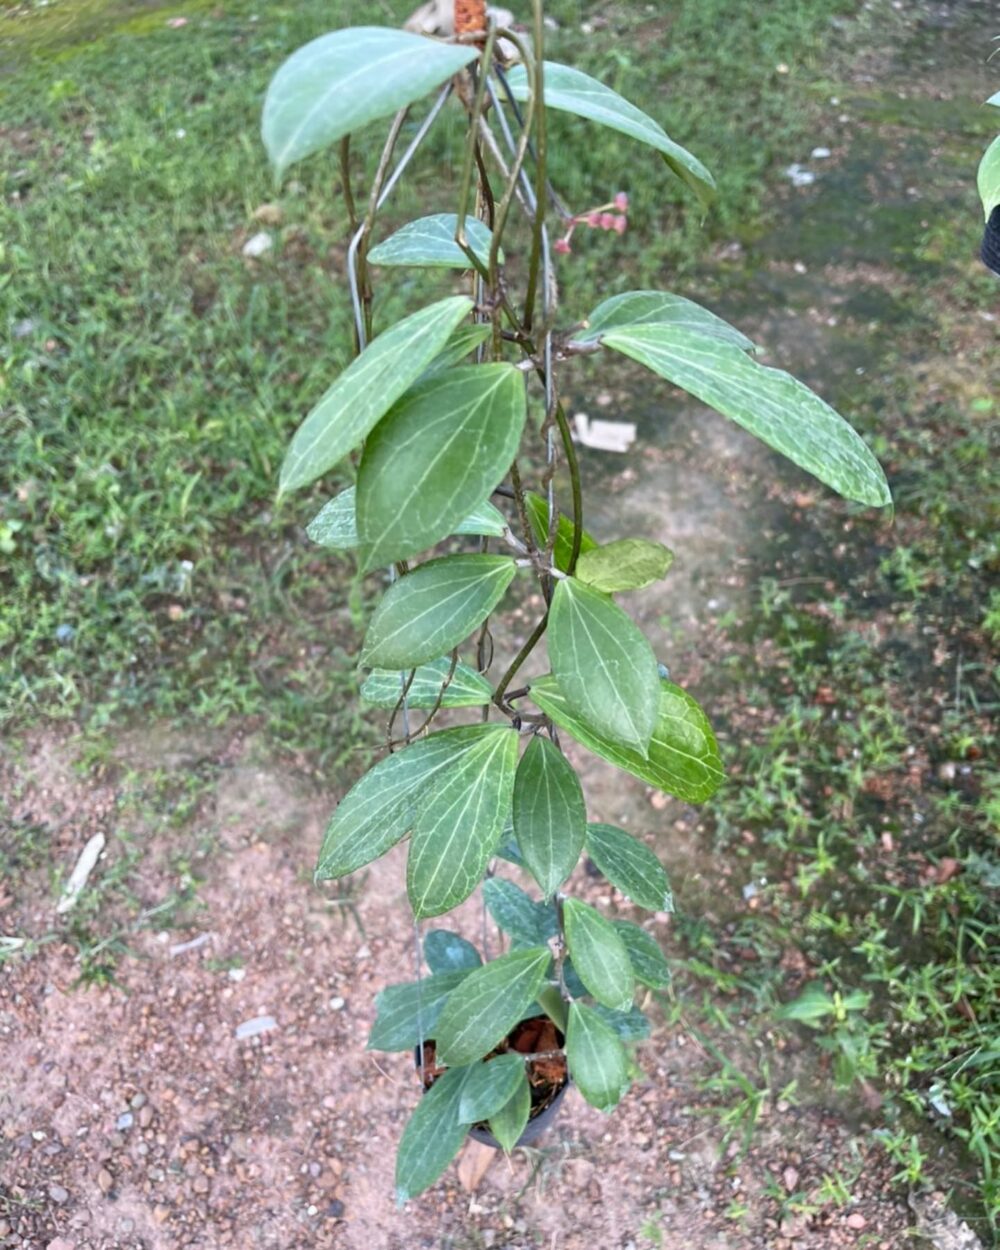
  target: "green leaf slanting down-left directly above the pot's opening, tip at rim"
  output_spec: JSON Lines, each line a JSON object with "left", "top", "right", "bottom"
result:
{"left": 435, "top": 946, "right": 551, "bottom": 1068}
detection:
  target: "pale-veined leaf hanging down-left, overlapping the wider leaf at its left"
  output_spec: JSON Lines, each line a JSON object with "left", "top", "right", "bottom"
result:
{"left": 406, "top": 725, "right": 518, "bottom": 920}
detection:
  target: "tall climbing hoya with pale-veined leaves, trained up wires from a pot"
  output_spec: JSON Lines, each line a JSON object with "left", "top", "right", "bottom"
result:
{"left": 263, "top": 0, "right": 890, "bottom": 1201}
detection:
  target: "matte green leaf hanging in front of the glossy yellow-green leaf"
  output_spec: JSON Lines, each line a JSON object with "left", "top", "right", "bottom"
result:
{"left": 548, "top": 578, "right": 660, "bottom": 755}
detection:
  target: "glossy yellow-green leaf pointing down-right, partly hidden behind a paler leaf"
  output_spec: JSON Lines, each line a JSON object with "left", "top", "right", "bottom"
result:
{"left": 531, "top": 674, "right": 723, "bottom": 803}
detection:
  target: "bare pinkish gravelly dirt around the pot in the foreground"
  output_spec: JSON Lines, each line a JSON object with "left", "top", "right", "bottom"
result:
{"left": 0, "top": 734, "right": 913, "bottom": 1250}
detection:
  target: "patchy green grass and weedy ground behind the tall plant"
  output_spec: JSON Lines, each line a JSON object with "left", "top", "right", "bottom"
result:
{"left": 0, "top": 0, "right": 1000, "bottom": 1245}
